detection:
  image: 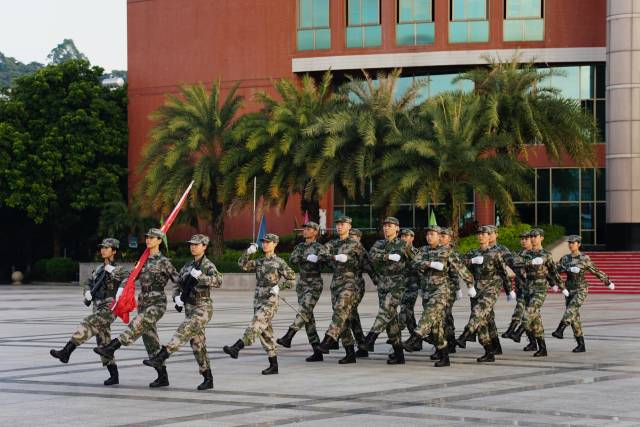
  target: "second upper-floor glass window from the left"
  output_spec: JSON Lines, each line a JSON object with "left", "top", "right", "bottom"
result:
{"left": 346, "top": 0, "right": 382, "bottom": 47}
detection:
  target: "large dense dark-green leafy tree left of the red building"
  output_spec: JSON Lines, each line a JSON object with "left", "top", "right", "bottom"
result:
{"left": 0, "top": 60, "right": 127, "bottom": 256}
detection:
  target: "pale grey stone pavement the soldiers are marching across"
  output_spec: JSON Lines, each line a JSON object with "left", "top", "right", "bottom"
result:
{"left": 0, "top": 285, "right": 640, "bottom": 427}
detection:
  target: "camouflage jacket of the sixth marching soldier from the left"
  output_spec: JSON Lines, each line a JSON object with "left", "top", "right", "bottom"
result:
{"left": 324, "top": 237, "right": 369, "bottom": 287}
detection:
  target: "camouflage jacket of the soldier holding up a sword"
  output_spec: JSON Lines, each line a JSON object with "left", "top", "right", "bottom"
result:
{"left": 238, "top": 253, "right": 296, "bottom": 307}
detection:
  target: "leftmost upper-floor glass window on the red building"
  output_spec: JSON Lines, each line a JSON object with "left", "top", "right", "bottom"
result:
{"left": 297, "top": 0, "right": 331, "bottom": 50}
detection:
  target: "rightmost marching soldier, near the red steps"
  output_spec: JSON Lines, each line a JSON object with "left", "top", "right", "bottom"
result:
{"left": 551, "top": 235, "right": 615, "bottom": 353}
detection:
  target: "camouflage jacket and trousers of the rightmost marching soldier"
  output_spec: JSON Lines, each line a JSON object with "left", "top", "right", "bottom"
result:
{"left": 558, "top": 253, "right": 611, "bottom": 337}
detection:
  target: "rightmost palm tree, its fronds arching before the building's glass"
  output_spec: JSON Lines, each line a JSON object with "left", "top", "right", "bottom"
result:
{"left": 457, "top": 55, "right": 598, "bottom": 167}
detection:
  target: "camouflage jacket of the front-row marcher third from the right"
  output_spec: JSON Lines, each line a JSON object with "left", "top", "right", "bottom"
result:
{"left": 465, "top": 245, "right": 511, "bottom": 293}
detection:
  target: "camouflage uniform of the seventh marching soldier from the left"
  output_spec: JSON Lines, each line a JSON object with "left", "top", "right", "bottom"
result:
{"left": 369, "top": 237, "right": 413, "bottom": 346}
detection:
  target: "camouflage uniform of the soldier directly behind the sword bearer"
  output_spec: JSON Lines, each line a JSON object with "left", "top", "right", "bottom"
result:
{"left": 289, "top": 242, "right": 326, "bottom": 345}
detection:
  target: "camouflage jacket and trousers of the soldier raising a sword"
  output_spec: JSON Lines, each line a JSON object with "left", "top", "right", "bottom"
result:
{"left": 238, "top": 253, "right": 296, "bottom": 357}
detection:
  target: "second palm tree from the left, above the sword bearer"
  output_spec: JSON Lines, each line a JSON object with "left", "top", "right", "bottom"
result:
{"left": 222, "top": 72, "right": 336, "bottom": 221}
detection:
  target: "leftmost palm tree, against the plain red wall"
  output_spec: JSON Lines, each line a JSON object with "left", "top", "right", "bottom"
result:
{"left": 138, "top": 81, "right": 243, "bottom": 256}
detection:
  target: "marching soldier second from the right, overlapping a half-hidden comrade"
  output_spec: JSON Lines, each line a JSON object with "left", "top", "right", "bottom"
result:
{"left": 514, "top": 228, "right": 569, "bottom": 357}
